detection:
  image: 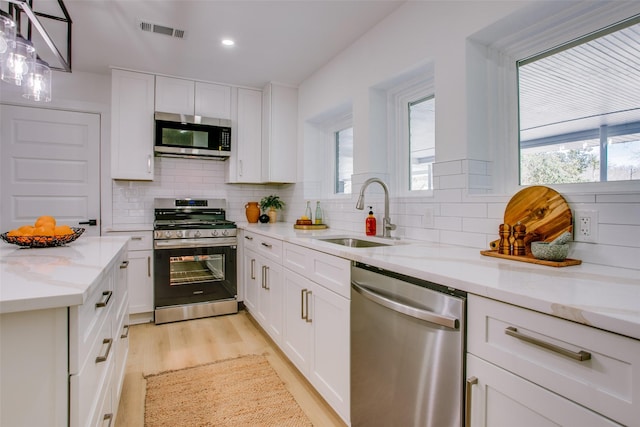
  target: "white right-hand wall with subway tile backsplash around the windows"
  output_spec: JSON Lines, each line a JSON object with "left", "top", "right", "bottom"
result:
{"left": 294, "top": 1, "right": 640, "bottom": 269}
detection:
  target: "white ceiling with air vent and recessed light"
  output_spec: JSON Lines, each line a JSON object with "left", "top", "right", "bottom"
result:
{"left": 28, "top": 0, "right": 404, "bottom": 87}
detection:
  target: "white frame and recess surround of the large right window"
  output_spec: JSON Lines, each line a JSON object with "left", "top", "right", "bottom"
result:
{"left": 467, "top": 2, "right": 640, "bottom": 195}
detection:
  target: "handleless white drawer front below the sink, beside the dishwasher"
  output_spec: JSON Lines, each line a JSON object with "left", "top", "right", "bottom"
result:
{"left": 283, "top": 242, "right": 351, "bottom": 299}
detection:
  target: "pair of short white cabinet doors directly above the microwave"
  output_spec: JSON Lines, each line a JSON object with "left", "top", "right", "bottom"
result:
{"left": 156, "top": 76, "right": 231, "bottom": 120}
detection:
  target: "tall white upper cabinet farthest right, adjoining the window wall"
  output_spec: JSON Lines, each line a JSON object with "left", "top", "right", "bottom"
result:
{"left": 262, "top": 83, "right": 298, "bottom": 183}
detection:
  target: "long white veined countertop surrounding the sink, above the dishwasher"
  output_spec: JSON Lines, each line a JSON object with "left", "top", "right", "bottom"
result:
{"left": 238, "top": 223, "right": 640, "bottom": 339}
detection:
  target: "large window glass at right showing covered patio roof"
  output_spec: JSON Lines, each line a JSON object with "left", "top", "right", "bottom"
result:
{"left": 517, "top": 16, "right": 640, "bottom": 185}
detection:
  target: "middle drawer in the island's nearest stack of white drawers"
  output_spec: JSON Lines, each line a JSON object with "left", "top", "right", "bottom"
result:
{"left": 69, "top": 307, "right": 116, "bottom": 426}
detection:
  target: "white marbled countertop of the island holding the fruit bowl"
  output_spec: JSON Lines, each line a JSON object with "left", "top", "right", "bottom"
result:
{"left": 0, "top": 236, "right": 129, "bottom": 314}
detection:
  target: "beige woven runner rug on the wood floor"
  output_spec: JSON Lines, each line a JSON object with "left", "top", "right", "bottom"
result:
{"left": 144, "top": 355, "right": 312, "bottom": 427}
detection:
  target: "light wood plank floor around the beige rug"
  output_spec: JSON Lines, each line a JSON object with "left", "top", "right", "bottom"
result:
{"left": 115, "top": 311, "right": 345, "bottom": 427}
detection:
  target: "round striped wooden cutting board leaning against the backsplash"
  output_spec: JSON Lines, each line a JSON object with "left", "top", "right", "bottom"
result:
{"left": 504, "top": 185, "right": 573, "bottom": 255}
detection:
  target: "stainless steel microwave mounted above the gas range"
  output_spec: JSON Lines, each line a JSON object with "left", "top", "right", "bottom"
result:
{"left": 154, "top": 112, "right": 231, "bottom": 160}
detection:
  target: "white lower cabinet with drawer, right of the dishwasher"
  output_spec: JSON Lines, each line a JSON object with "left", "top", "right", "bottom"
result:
{"left": 466, "top": 295, "right": 640, "bottom": 427}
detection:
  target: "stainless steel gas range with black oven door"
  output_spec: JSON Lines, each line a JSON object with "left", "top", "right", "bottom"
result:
{"left": 153, "top": 198, "right": 238, "bottom": 324}
